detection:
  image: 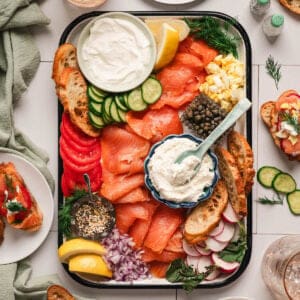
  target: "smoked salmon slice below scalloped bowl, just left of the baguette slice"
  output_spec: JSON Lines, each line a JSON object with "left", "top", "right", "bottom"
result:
{"left": 144, "top": 205, "right": 184, "bottom": 253}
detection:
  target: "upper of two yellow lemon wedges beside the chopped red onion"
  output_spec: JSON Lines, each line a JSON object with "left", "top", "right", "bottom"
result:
{"left": 58, "top": 238, "right": 106, "bottom": 263}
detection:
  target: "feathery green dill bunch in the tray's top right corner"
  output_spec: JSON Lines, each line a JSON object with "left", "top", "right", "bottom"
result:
{"left": 185, "top": 16, "right": 240, "bottom": 58}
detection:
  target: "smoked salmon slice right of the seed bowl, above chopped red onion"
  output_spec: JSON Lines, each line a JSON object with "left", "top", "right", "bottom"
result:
{"left": 115, "top": 203, "right": 149, "bottom": 234}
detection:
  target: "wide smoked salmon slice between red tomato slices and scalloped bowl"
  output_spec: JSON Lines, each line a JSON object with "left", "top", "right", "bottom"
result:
{"left": 101, "top": 125, "right": 150, "bottom": 174}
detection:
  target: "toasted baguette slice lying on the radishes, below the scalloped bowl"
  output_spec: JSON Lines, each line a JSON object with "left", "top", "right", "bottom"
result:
{"left": 183, "top": 180, "right": 228, "bottom": 244}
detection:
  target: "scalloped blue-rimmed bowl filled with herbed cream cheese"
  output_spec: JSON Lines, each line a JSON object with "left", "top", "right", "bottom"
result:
{"left": 144, "top": 134, "right": 220, "bottom": 208}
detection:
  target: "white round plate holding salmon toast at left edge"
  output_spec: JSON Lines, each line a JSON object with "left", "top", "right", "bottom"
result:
{"left": 0, "top": 153, "right": 54, "bottom": 264}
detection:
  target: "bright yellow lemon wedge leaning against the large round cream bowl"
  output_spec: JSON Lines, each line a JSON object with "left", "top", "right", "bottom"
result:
{"left": 154, "top": 23, "right": 179, "bottom": 70}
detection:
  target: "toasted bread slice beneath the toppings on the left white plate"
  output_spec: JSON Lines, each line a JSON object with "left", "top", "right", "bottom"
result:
{"left": 0, "top": 162, "right": 43, "bottom": 231}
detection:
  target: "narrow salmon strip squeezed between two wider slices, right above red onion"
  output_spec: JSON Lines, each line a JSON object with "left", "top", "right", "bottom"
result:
{"left": 128, "top": 200, "right": 159, "bottom": 248}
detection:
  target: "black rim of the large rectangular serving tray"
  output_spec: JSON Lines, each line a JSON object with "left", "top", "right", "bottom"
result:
{"left": 58, "top": 11, "right": 252, "bottom": 289}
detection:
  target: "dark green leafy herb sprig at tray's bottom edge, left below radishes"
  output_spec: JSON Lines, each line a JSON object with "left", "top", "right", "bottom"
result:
{"left": 166, "top": 258, "right": 215, "bottom": 293}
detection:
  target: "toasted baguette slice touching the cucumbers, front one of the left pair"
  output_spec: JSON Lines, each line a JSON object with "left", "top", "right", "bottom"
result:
{"left": 58, "top": 68, "right": 100, "bottom": 137}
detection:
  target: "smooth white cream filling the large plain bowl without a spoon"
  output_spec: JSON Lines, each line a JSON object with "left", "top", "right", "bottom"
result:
{"left": 82, "top": 17, "right": 151, "bottom": 87}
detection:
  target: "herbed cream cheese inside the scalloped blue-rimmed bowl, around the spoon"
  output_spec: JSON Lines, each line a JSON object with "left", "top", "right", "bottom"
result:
{"left": 148, "top": 138, "right": 214, "bottom": 203}
